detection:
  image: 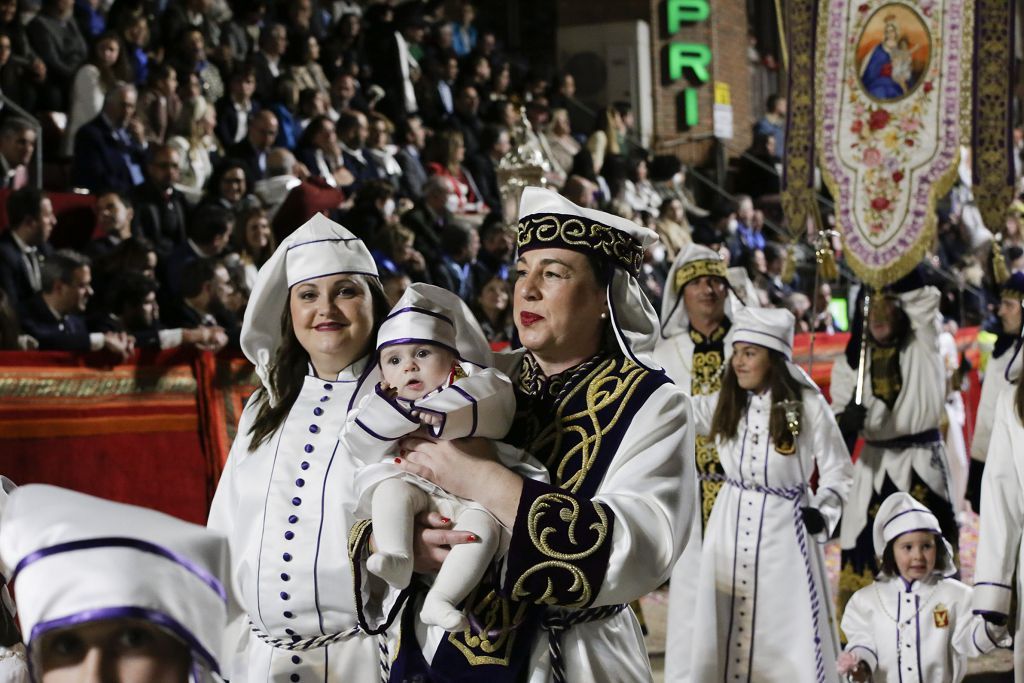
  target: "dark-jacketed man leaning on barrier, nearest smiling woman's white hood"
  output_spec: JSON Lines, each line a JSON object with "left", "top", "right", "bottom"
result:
{"left": 161, "top": 258, "right": 242, "bottom": 348}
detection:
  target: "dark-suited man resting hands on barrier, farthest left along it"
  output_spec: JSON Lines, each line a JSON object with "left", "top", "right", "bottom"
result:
{"left": 20, "top": 250, "right": 134, "bottom": 361}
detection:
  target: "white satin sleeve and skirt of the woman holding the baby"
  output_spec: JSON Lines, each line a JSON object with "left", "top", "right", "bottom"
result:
{"left": 361, "top": 352, "right": 697, "bottom": 683}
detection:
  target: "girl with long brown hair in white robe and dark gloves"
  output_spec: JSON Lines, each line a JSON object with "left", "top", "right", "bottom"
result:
{"left": 691, "top": 308, "right": 852, "bottom": 683}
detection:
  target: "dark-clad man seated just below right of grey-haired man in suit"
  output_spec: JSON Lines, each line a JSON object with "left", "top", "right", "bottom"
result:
{"left": 132, "top": 144, "right": 187, "bottom": 256}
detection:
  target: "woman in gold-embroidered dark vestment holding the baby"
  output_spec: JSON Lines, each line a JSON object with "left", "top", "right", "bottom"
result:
{"left": 353, "top": 187, "right": 696, "bottom": 683}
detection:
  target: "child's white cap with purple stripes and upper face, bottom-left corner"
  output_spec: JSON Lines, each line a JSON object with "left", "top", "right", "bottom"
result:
{"left": 0, "top": 484, "right": 229, "bottom": 683}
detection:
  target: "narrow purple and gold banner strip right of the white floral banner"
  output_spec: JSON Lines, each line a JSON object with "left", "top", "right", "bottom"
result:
{"left": 971, "top": 0, "right": 1016, "bottom": 232}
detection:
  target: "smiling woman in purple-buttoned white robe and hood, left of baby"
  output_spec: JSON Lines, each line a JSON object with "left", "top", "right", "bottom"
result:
{"left": 209, "top": 214, "right": 388, "bottom": 683}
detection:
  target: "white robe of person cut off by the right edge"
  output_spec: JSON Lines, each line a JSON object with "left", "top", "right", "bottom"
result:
{"left": 973, "top": 385, "right": 1024, "bottom": 683}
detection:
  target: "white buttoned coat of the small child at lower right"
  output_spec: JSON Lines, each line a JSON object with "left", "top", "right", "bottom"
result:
{"left": 843, "top": 574, "right": 996, "bottom": 683}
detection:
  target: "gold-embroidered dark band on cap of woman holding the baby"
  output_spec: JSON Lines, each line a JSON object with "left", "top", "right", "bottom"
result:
{"left": 517, "top": 214, "right": 644, "bottom": 276}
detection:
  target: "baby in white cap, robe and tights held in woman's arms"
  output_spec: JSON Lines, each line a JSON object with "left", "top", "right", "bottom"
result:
{"left": 342, "top": 284, "right": 540, "bottom": 631}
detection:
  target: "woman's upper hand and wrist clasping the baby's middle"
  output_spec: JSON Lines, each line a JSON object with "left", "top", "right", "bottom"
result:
{"left": 395, "top": 429, "right": 522, "bottom": 528}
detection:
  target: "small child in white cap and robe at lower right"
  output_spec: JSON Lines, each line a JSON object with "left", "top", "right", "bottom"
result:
{"left": 838, "top": 493, "right": 1010, "bottom": 683}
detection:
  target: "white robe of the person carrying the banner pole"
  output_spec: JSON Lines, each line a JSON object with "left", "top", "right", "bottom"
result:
{"left": 829, "top": 287, "right": 949, "bottom": 550}
